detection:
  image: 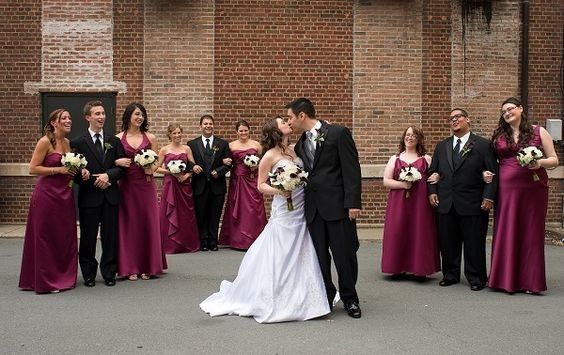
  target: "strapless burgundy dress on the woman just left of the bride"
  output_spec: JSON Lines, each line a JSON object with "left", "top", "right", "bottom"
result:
{"left": 219, "top": 148, "right": 266, "bottom": 249}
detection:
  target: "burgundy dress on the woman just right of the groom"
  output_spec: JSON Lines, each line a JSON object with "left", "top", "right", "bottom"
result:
{"left": 382, "top": 156, "right": 441, "bottom": 276}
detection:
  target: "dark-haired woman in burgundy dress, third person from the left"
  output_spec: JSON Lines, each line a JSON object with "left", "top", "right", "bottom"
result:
{"left": 116, "top": 103, "right": 166, "bottom": 281}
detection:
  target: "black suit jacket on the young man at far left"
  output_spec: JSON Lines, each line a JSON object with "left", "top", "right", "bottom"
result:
{"left": 71, "top": 132, "right": 125, "bottom": 207}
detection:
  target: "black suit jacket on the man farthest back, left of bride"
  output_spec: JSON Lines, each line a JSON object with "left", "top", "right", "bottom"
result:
{"left": 188, "top": 136, "right": 231, "bottom": 195}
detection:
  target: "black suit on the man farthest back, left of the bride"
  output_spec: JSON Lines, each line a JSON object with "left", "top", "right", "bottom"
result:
{"left": 188, "top": 136, "right": 231, "bottom": 248}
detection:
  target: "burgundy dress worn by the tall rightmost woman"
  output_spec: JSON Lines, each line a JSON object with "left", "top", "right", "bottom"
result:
{"left": 488, "top": 126, "right": 548, "bottom": 292}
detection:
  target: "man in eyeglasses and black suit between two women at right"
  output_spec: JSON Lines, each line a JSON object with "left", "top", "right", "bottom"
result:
{"left": 428, "top": 108, "right": 498, "bottom": 291}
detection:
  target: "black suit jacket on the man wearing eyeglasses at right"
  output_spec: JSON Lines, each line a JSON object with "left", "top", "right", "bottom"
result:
{"left": 428, "top": 133, "right": 498, "bottom": 216}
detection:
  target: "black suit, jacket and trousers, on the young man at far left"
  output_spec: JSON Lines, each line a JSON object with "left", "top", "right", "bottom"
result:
{"left": 71, "top": 132, "right": 125, "bottom": 280}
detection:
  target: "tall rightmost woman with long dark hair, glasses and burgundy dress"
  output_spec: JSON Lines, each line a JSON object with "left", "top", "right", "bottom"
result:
{"left": 485, "top": 97, "right": 558, "bottom": 294}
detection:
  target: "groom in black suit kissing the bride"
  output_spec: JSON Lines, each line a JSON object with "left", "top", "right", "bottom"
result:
{"left": 286, "top": 98, "right": 362, "bottom": 318}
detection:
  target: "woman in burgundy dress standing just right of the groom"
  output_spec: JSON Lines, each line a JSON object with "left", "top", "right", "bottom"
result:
{"left": 382, "top": 127, "right": 440, "bottom": 280}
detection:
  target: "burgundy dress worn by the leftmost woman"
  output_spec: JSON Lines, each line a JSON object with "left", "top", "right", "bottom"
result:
{"left": 19, "top": 152, "right": 78, "bottom": 293}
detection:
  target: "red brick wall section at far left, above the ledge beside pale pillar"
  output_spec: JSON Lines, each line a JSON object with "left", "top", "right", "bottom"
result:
{"left": 0, "top": 0, "right": 41, "bottom": 164}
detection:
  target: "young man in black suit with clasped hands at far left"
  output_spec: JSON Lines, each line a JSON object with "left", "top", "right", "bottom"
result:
{"left": 71, "top": 101, "right": 125, "bottom": 287}
